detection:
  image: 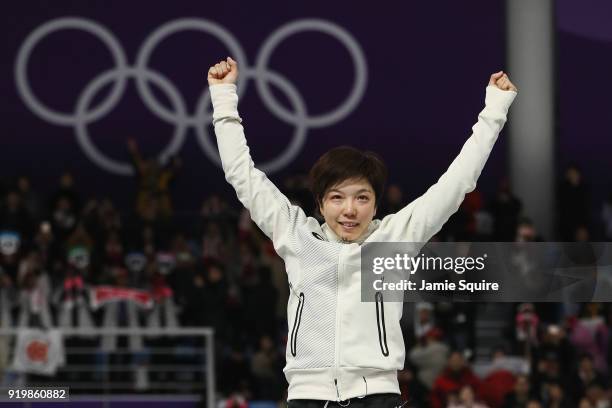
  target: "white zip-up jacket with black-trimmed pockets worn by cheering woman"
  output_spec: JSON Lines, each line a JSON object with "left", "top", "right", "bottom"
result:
{"left": 210, "top": 84, "right": 516, "bottom": 401}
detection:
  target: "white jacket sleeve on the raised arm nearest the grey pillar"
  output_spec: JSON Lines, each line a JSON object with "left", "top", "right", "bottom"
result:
{"left": 379, "top": 86, "right": 516, "bottom": 242}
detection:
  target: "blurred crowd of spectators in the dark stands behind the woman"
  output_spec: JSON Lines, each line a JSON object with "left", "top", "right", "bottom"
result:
{"left": 0, "top": 159, "right": 612, "bottom": 408}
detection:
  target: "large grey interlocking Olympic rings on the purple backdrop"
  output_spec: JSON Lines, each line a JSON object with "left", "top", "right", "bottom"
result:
{"left": 15, "top": 17, "right": 367, "bottom": 176}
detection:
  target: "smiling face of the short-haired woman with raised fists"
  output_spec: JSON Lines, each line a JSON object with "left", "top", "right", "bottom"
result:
{"left": 320, "top": 179, "right": 376, "bottom": 242}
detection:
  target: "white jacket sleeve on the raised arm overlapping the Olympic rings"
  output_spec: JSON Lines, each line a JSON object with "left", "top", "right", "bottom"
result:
{"left": 210, "top": 84, "right": 307, "bottom": 256}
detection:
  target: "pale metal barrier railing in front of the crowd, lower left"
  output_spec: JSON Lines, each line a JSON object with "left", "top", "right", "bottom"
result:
{"left": 0, "top": 327, "right": 215, "bottom": 408}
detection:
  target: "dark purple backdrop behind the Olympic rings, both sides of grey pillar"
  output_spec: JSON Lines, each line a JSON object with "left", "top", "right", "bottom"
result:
{"left": 0, "top": 0, "right": 612, "bottom": 220}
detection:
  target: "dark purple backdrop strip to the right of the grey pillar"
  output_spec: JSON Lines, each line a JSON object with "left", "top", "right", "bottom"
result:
{"left": 557, "top": 0, "right": 612, "bottom": 219}
